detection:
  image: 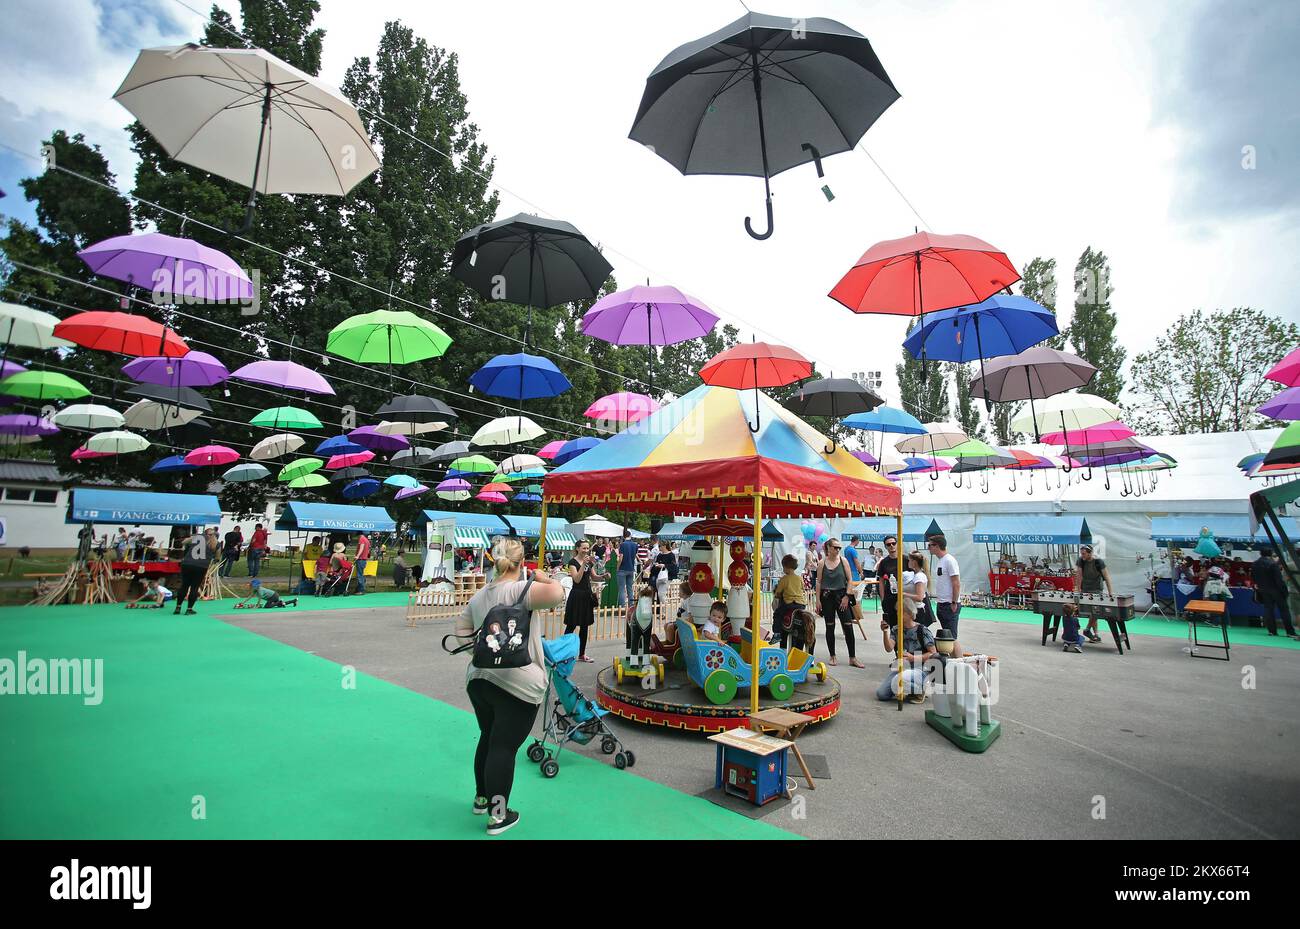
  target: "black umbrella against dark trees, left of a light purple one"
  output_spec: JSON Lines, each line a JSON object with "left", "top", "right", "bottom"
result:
{"left": 451, "top": 213, "right": 614, "bottom": 346}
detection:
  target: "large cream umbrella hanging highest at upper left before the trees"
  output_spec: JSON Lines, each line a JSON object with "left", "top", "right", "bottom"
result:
{"left": 113, "top": 44, "right": 380, "bottom": 231}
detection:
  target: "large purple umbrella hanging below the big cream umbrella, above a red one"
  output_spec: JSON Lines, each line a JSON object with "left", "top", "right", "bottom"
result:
{"left": 77, "top": 233, "right": 254, "bottom": 300}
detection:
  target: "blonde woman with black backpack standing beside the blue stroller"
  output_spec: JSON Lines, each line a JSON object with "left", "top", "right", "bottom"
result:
{"left": 456, "top": 537, "right": 564, "bottom": 835}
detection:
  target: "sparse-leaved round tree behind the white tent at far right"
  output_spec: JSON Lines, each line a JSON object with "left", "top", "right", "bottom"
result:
{"left": 1127, "top": 307, "right": 1300, "bottom": 435}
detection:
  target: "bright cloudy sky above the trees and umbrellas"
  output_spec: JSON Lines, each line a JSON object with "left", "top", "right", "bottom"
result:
{"left": 0, "top": 0, "right": 1300, "bottom": 413}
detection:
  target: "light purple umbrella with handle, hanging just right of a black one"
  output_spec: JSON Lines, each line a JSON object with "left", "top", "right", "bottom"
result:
{"left": 582, "top": 285, "right": 718, "bottom": 387}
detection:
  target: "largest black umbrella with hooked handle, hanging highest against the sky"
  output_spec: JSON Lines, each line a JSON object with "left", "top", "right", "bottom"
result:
{"left": 628, "top": 13, "right": 898, "bottom": 239}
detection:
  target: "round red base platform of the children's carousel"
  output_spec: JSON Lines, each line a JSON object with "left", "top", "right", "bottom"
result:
{"left": 597, "top": 667, "right": 840, "bottom": 733}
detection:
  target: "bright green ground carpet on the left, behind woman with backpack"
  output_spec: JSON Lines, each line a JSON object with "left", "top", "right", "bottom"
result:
{"left": 0, "top": 594, "right": 790, "bottom": 839}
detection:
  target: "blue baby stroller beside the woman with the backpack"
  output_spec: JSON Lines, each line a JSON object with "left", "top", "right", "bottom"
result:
{"left": 528, "top": 633, "right": 637, "bottom": 777}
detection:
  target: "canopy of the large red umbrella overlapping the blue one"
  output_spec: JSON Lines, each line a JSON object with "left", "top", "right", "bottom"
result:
{"left": 829, "top": 233, "right": 1021, "bottom": 316}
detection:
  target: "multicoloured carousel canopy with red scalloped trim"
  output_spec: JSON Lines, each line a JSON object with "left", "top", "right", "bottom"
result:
{"left": 542, "top": 385, "right": 901, "bottom": 517}
